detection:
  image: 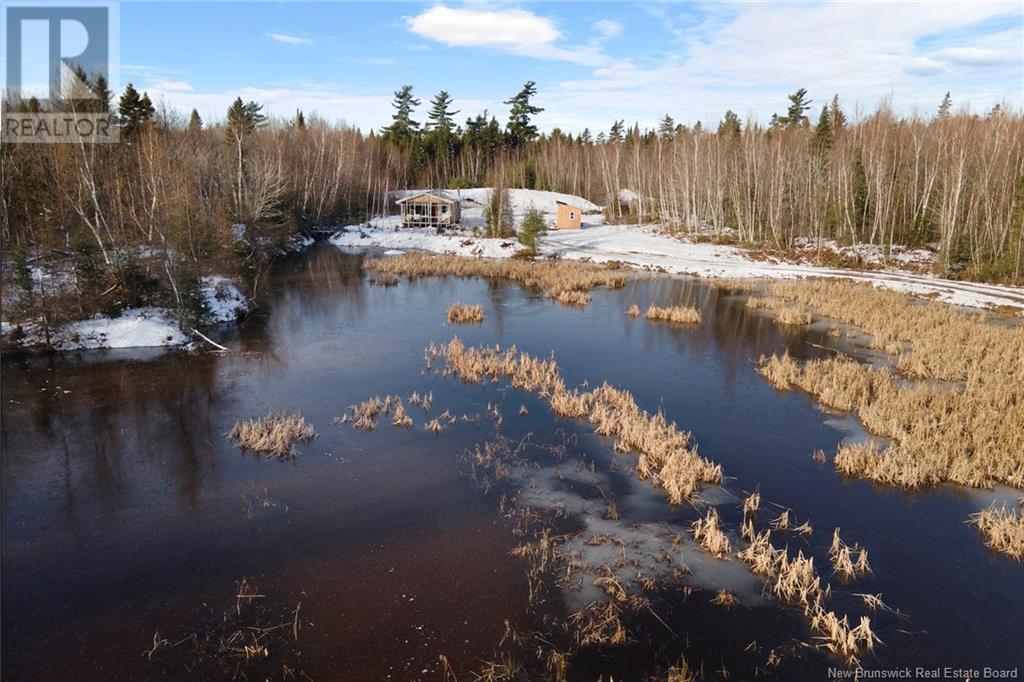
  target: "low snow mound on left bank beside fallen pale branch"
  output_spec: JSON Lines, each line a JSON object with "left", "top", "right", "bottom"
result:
{"left": 54, "top": 308, "right": 188, "bottom": 350}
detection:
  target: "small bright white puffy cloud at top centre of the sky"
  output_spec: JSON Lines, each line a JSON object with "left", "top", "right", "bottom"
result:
{"left": 406, "top": 5, "right": 607, "bottom": 65}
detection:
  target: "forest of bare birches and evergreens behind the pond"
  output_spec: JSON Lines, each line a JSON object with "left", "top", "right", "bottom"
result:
{"left": 2, "top": 75, "right": 1024, "bottom": 335}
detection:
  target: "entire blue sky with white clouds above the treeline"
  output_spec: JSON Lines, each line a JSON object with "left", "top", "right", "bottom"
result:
{"left": 105, "top": 2, "right": 1024, "bottom": 131}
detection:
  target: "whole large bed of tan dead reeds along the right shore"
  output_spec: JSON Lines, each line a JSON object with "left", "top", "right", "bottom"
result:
{"left": 762, "top": 281, "right": 1024, "bottom": 499}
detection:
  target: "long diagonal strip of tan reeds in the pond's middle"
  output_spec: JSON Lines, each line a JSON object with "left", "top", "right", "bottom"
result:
{"left": 427, "top": 338, "right": 722, "bottom": 504}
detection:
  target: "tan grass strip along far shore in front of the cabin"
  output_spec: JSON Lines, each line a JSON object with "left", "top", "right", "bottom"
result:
{"left": 365, "top": 253, "right": 626, "bottom": 305}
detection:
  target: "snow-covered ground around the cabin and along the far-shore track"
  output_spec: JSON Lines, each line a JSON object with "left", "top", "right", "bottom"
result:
{"left": 331, "top": 188, "right": 1024, "bottom": 310}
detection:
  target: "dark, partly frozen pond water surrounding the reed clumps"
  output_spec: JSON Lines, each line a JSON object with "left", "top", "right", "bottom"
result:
{"left": 0, "top": 244, "right": 1024, "bottom": 680}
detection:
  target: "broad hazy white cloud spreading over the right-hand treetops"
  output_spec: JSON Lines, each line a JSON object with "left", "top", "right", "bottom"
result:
{"left": 539, "top": 2, "right": 1024, "bottom": 129}
